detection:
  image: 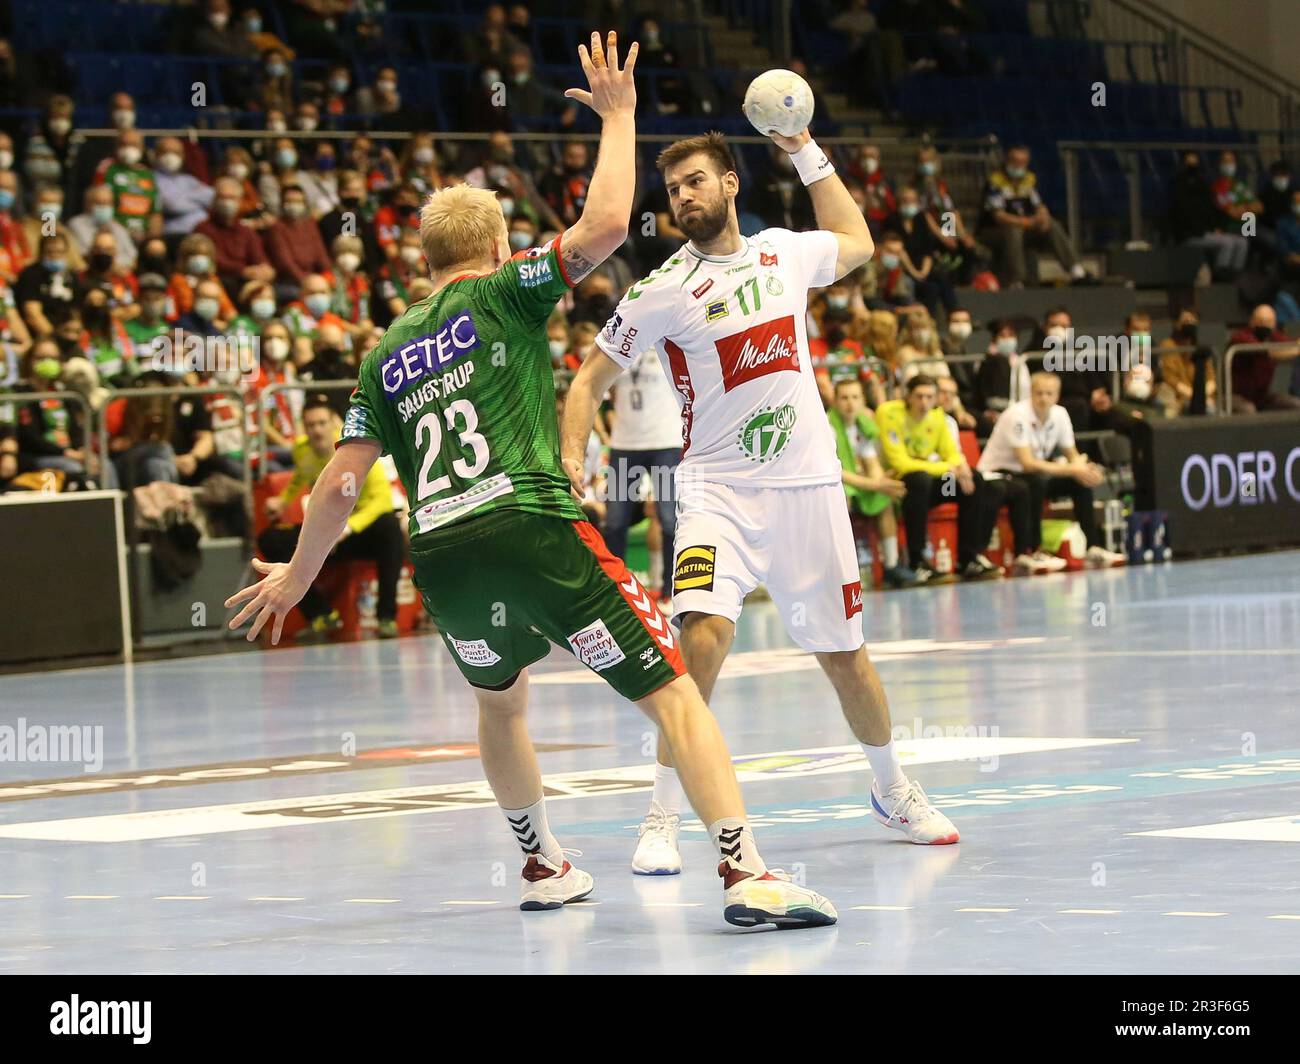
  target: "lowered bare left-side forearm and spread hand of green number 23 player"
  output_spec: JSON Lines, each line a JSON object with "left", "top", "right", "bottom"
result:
{"left": 226, "top": 440, "right": 381, "bottom": 644}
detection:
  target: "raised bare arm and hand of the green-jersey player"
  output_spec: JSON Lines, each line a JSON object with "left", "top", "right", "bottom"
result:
{"left": 560, "top": 30, "right": 637, "bottom": 285}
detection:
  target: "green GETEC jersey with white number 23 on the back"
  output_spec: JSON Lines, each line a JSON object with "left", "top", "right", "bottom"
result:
{"left": 339, "top": 238, "right": 585, "bottom": 541}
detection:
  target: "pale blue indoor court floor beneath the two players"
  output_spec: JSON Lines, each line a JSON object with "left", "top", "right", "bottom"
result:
{"left": 0, "top": 553, "right": 1300, "bottom": 973}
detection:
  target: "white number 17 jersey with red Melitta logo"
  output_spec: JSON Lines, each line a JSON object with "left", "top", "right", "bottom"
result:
{"left": 597, "top": 229, "right": 840, "bottom": 488}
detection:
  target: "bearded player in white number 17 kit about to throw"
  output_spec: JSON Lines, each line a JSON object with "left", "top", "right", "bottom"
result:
{"left": 562, "top": 130, "right": 958, "bottom": 875}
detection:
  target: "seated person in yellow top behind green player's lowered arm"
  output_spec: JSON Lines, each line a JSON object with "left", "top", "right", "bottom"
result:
{"left": 257, "top": 395, "right": 406, "bottom": 639}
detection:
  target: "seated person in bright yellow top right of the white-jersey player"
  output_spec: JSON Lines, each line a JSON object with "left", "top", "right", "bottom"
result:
{"left": 876, "top": 373, "right": 1002, "bottom": 583}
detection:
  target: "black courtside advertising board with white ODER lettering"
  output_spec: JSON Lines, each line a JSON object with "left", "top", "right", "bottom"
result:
{"left": 1132, "top": 412, "right": 1300, "bottom": 554}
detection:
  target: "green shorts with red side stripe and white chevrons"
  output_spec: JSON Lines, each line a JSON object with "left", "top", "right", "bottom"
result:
{"left": 411, "top": 510, "right": 686, "bottom": 701}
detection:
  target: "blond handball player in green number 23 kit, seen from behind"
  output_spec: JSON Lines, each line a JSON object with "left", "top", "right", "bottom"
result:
{"left": 226, "top": 33, "right": 836, "bottom": 927}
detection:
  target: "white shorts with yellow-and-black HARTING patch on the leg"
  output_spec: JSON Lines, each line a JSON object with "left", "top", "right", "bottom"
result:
{"left": 672, "top": 480, "right": 863, "bottom": 653}
